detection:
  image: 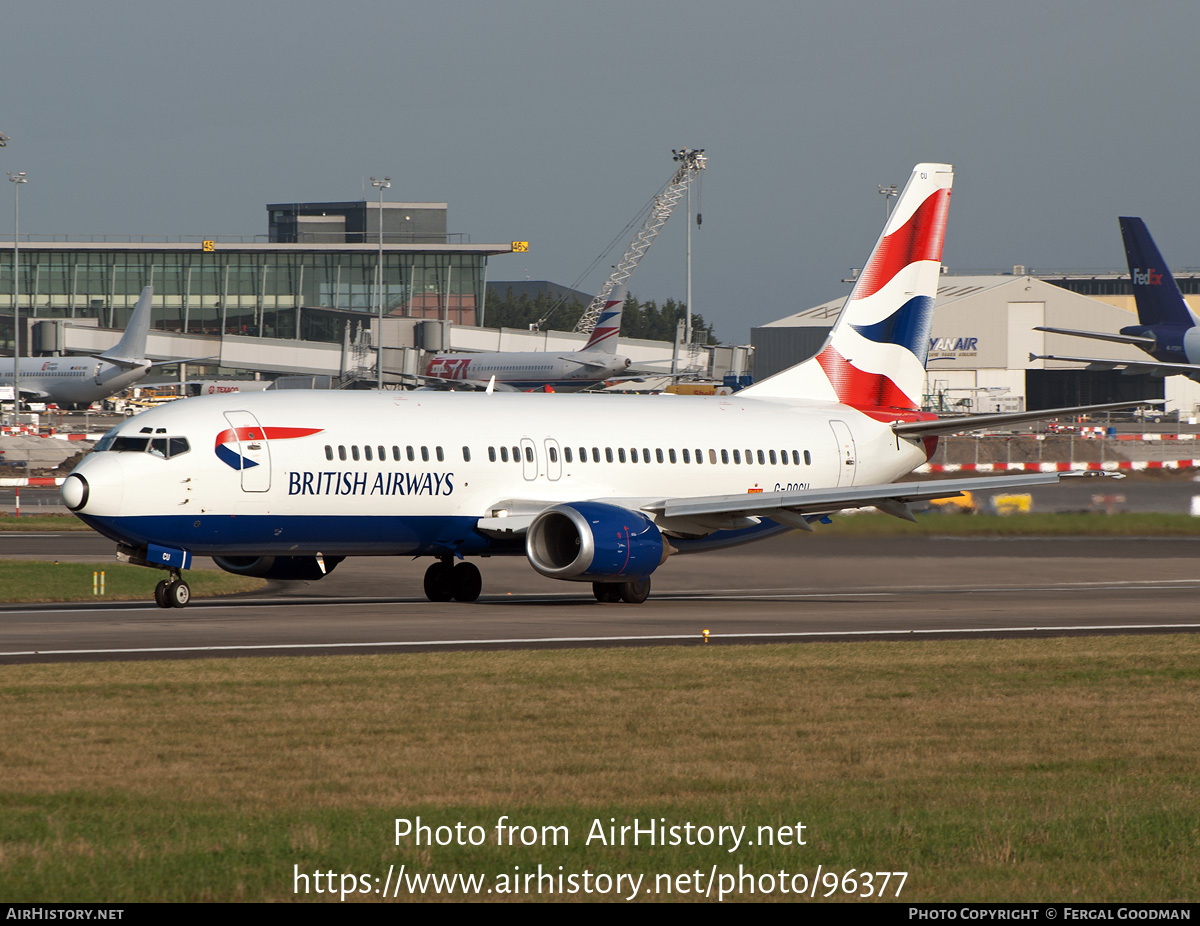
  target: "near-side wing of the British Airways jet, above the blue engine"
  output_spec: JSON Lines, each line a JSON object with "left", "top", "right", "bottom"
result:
{"left": 475, "top": 473, "right": 1058, "bottom": 536}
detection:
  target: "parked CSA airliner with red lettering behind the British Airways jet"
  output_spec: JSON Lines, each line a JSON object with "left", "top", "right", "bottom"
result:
{"left": 424, "top": 283, "right": 630, "bottom": 392}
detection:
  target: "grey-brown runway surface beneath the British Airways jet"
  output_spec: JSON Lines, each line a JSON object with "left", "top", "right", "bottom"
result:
{"left": 7, "top": 534, "right": 1200, "bottom": 663}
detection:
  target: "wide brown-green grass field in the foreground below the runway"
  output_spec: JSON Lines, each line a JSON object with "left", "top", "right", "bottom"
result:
{"left": 0, "top": 636, "right": 1200, "bottom": 902}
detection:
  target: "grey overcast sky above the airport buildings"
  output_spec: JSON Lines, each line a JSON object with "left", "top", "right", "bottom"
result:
{"left": 0, "top": 0, "right": 1200, "bottom": 343}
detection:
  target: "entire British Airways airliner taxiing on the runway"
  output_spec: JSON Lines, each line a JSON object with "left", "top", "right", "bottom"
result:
{"left": 62, "top": 164, "right": 1132, "bottom": 607}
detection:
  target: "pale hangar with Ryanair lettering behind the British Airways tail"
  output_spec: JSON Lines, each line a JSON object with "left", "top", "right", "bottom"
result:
{"left": 751, "top": 266, "right": 1200, "bottom": 420}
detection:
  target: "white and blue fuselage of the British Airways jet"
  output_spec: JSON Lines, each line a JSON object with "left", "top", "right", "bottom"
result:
{"left": 65, "top": 391, "right": 925, "bottom": 555}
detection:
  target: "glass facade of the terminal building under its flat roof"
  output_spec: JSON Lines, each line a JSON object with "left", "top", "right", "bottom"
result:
{"left": 0, "top": 240, "right": 511, "bottom": 351}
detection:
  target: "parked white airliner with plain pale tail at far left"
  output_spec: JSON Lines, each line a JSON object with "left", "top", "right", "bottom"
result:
{"left": 0, "top": 287, "right": 162, "bottom": 405}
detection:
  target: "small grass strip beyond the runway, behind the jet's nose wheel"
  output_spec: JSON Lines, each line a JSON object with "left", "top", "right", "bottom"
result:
{"left": 0, "top": 559, "right": 266, "bottom": 602}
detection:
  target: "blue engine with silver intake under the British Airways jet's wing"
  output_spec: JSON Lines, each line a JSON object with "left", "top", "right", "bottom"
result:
{"left": 526, "top": 501, "right": 670, "bottom": 582}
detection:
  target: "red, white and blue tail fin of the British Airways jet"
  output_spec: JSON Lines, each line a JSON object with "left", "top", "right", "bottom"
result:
{"left": 740, "top": 164, "right": 954, "bottom": 410}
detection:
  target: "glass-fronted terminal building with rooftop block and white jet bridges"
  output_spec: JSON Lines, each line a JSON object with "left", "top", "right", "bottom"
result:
{"left": 0, "top": 202, "right": 748, "bottom": 385}
